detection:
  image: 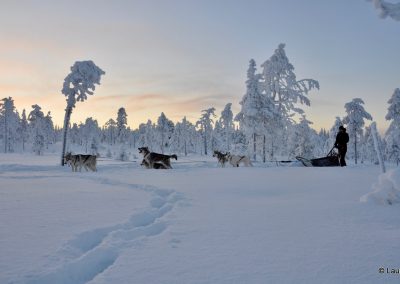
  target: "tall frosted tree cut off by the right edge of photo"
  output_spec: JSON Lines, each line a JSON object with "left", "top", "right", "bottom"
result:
{"left": 385, "top": 88, "right": 400, "bottom": 165}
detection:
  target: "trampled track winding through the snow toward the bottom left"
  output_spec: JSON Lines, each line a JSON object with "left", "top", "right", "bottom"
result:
{"left": 9, "top": 169, "right": 184, "bottom": 284}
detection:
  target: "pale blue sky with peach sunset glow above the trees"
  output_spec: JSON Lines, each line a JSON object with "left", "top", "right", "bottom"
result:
{"left": 0, "top": 0, "right": 400, "bottom": 131}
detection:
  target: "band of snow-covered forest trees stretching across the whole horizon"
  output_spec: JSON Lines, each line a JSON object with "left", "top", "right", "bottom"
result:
{"left": 0, "top": 44, "right": 400, "bottom": 164}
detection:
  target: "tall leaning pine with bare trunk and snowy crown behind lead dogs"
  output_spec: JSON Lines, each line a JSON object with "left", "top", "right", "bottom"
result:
{"left": 61, "top": 60, "right": 105, "bottom": 166}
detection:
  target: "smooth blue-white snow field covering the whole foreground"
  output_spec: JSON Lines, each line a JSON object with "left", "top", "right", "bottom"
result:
{"left": 0, "top": 154, "right": 400, "bottom": 284}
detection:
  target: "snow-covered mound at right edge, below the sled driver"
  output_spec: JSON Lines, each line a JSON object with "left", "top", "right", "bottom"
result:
{"left": 360, "top": 168, "right": 400, "bottom": 205}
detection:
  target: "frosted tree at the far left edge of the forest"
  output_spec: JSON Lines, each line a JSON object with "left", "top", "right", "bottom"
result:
{"left": 0, "top": 97, "right": 19, "bottom": 153}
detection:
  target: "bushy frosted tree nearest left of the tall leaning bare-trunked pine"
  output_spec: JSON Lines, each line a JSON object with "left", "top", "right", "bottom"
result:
{"left": 28, "top": 105, "right": 45, "bottom": 155}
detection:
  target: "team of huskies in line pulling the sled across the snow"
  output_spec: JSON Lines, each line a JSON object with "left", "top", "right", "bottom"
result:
{"left": 64, "top": 147, "right": 253, "bottom": 172}
